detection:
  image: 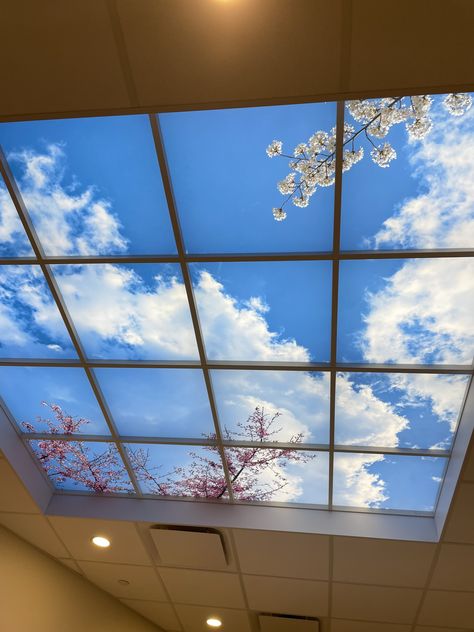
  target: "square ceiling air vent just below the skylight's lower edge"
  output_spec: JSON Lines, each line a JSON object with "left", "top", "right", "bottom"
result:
{"left": 150, "top": 527, "right": 227, "bottom": 570}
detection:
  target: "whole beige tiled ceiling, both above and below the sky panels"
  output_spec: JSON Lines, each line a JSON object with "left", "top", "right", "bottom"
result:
{"left": 0, "top": 0, "right": 474, "bottom": 632}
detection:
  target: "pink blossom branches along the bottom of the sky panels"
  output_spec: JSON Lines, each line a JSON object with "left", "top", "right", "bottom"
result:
{"left": 22, "top": 402, "right": 315, "bottom": 501}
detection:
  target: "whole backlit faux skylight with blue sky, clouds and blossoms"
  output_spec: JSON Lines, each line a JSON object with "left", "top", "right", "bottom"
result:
{"left": 0, "top": 96, "right": 474, "bottom": 515}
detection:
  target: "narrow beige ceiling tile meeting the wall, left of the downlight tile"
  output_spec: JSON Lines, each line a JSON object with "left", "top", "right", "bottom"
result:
{"left": 0, "top": 513, "right": 69, "bottom": 557}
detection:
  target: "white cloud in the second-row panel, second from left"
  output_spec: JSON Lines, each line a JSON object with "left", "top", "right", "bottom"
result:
{"left": 55, "top": 264, "right": 197, "bottom": 360}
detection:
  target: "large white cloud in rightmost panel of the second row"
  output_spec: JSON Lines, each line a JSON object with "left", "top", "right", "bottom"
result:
{"left": 362, "top": 258, "right": 474, "bottom": 364}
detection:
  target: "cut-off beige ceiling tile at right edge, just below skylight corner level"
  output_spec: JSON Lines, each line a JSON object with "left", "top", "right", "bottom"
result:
{"left": 430, "top": 544, "right": 474, "bottom": 592}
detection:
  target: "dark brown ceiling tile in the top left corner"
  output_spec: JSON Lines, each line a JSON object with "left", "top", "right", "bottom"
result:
{"left": 0, "top": 0, "right": 130, "bottom": 115}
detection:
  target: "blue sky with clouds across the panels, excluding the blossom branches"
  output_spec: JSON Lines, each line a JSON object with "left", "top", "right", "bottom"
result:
{"left": 0, "top": 92, "right": 474, "bottom": 511}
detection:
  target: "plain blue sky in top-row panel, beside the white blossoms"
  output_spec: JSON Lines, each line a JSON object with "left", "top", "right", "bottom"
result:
{"left": 160, "top": 103, "right": 336, "bottom": 253}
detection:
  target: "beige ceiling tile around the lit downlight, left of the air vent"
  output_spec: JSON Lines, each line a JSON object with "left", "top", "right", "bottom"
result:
{"left": 49, "top": 516, "right": 151, "bottom": 564}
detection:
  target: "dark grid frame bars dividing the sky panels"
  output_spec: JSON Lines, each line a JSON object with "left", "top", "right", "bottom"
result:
{"left": 0, "top": 91, "right": 474, "bottom": 515}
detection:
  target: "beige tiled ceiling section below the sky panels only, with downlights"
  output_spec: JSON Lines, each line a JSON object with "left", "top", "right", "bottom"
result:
{"left": 0, "top": 445, "right": 474, "bottom": 632}
